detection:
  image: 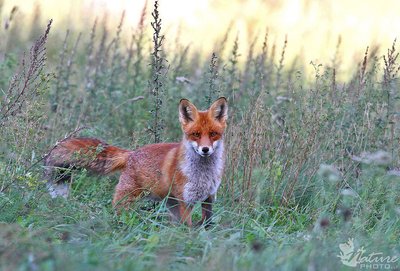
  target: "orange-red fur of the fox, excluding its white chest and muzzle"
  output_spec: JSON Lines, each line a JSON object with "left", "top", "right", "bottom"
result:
{"left": 46, "top": 98, "right": 226, "bottom": 225}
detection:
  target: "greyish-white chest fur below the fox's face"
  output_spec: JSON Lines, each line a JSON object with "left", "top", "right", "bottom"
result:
{"left": 180, "top": 140, "right": 224, "bottom": 204}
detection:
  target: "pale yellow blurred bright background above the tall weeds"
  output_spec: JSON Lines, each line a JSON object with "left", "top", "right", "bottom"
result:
{"left": 3, "top": 0, "right": 400, "bottom": 77}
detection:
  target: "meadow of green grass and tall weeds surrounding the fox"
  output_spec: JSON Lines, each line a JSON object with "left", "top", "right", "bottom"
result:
{"left": 0, "top": 2, "right": 400, "bottom": 270}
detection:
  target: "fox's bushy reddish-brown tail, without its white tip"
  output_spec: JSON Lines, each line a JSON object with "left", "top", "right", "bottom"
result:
{"left": 45, "top": 138, "right": 129, "bottom": 174}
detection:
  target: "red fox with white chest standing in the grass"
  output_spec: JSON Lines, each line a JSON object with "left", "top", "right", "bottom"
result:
{"left": 45, "top": 97, "right": 228, "bottom": 226}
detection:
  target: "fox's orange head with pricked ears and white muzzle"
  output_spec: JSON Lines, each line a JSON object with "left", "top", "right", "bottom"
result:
{"left": 179, "top": 97, "right": 228, "bottom": 157}
